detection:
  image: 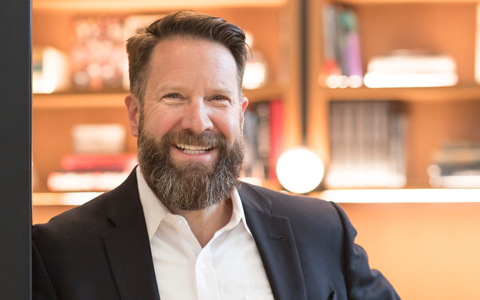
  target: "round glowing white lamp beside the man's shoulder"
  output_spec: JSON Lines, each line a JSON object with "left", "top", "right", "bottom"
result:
{"left": 277, "top": 148, "right": 324, "bottom": 194}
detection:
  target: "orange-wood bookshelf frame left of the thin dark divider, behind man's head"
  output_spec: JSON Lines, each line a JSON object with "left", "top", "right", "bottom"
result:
{"left": 32, "top": 0, "right": 300, "bottom": 195}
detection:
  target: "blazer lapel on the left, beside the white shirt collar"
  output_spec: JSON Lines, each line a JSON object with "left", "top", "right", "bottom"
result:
{"left": 103, "top": 170, "right": 160, "bottom": 300}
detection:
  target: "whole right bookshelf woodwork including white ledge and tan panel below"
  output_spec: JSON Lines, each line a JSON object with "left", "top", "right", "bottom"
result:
{"left": 307, "top": 0, "right": 480, "bottom": 300}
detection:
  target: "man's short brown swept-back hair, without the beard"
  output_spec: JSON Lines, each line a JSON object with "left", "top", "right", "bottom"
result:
{"left": 127, "top": 10, "right": 247, "bottom": 108}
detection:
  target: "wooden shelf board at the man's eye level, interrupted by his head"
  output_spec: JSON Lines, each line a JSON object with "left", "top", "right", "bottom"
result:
{"left": 32, "top": 85, "right": 285, "bottom": 109}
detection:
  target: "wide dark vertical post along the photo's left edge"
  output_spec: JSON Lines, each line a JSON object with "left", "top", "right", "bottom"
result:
{"left": 0, "top": 0, "right": 32, "bottom": 300}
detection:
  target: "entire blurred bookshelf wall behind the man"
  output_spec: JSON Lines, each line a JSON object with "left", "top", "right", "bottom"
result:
{"left": 32, "top": 0, "right": 480, "bottom": 300}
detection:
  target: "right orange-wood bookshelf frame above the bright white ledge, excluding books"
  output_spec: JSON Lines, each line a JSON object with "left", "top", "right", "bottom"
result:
{"left": 307, "top": 0, "right": 480, "bottom": 188}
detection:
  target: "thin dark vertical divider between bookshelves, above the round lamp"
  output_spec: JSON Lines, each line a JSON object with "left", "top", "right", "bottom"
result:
{"left": 300, "top": 0, "right": 308, "bottom": 146}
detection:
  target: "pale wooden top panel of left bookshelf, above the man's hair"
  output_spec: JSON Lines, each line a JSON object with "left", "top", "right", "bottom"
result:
{"left": 32, "top": 0, "right": 287, "bottom": 12}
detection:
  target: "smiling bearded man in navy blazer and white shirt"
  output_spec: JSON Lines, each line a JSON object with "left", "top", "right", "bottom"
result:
{"left": 33, "top": 11, "right": 399, "bottom": 300}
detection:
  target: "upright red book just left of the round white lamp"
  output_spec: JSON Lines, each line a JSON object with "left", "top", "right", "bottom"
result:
{"left": 268, "top": 99, "right": 283, "bottom": 180}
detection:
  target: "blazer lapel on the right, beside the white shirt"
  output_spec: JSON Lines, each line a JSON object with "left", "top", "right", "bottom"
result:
{"left": 238, "top": 183, "right": 306, "bottom": 300}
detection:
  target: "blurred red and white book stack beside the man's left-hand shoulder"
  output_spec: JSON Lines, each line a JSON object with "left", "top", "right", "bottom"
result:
{"left": 47, "top": 124, "right": 137, "bottom": 192}
